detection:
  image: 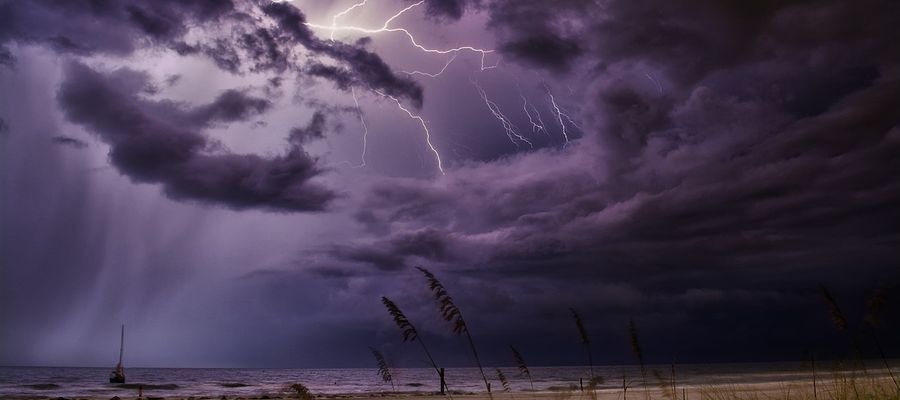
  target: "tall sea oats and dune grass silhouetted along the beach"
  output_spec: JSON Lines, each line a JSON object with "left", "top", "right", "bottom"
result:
{"left": 372, "top": 267, "right": 900, "bottom": 400}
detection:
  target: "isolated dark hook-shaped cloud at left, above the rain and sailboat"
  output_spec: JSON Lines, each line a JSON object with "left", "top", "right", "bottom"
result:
{"left": 58, "top": 63, "right": 334, "bottom": 211}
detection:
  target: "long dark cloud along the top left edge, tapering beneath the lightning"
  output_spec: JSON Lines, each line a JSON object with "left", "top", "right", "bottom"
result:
{"left": 0, "top": 0, "right": 423, "bottom": 107}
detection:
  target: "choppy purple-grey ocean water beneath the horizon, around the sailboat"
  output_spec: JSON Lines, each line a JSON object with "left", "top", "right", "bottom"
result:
{"left": 0, "top": 361, "right": 900, "bottom": 398}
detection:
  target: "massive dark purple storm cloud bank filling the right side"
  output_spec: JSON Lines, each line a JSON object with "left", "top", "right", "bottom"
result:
{"left": 312, "top": 1, "right": 900, "bottom": 358}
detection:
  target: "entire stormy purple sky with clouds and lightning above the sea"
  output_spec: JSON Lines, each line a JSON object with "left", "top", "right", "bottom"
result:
{"left": 0, "top": 0, "right": 900, "bottom": 367}
